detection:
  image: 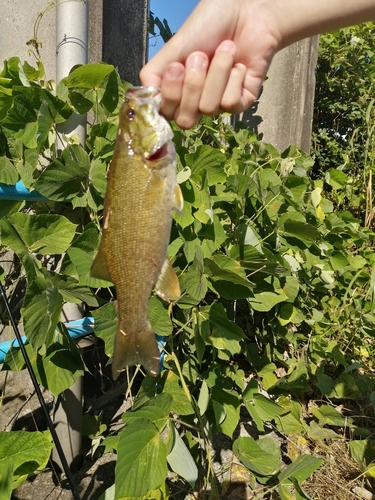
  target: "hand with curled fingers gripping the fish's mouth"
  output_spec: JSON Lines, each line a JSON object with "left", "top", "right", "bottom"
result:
{"left": 140, "top": 0, "right": 281, "bottom": 129}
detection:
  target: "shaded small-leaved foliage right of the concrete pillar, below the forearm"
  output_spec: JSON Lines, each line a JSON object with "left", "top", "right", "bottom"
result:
{"left": 313, "top": 22, "right": 375, "bottom": 226}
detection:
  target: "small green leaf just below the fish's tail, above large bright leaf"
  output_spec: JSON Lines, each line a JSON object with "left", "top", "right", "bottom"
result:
{"left": 122, "top": 393, "right": 173, "bottom": 431}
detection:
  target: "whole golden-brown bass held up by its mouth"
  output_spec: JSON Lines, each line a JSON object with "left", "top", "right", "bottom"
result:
{"left": 91, "top": 87, "right": 183, "bottom": 380}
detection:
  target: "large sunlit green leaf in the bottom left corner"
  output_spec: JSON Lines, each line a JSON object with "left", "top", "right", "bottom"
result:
{"left": 0, "top": 431, "right": 53, "bottom": 484}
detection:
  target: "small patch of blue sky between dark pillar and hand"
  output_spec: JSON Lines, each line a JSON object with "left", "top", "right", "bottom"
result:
{"left": 149, "top": 0, "right": 199, "bottom": 58}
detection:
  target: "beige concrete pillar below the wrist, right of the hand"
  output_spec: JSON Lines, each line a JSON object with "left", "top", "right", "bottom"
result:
{"left": 244, "top": 37, "right": 319, "bottom": 152}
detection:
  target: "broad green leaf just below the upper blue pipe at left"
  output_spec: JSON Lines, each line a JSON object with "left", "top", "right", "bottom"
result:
{"left": 8, "top": 213, "right": 77, "bottom": 255}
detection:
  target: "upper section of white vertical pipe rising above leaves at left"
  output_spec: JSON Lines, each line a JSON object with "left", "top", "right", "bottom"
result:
{"left": 56, "top": 0, "right": 88, "bottom": 149}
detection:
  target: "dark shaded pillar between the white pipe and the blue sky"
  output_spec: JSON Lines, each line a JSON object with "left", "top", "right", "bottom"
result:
{"left": 103, "top": 0, "right": 148, "bottom": 85}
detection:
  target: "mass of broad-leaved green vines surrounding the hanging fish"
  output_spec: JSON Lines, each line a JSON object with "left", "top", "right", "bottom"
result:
{"left": 0, "top": 58, "right": 375, "bottom": 500}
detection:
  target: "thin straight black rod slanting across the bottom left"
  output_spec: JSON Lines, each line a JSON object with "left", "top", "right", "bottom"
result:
{"left": 0, "top": 283, "right": 80, "bottom": 500}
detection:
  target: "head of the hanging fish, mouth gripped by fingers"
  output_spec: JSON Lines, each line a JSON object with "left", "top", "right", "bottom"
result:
{"left": 119, "top": 87, "right": 173, "bottom": 160}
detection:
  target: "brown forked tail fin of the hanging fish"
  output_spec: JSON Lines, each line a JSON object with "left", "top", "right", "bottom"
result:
{"left": 112, "top": 322, "right": 160, "bottom": 380}
